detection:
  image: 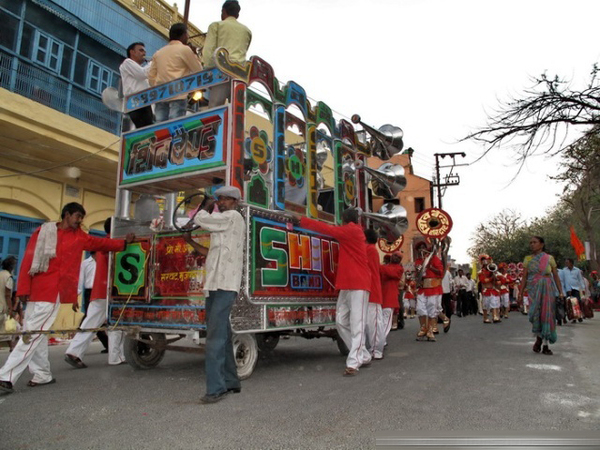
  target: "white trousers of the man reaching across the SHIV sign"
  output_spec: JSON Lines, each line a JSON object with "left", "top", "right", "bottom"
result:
{"left": 335, "top": 289, "right": 371, "bottom": 369}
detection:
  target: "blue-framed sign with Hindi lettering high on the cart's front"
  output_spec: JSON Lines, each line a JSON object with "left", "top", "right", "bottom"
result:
{"left": 120, "top": 107, "right": 228, "bottom": 185}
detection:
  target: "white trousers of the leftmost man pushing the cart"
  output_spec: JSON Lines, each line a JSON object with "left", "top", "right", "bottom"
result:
{"left": 0, "top": 298, "right": 60, "bottom": 383}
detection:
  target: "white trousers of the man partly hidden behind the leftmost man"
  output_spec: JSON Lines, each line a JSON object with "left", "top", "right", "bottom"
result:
{"left": 65, "top": 299, "right": 125, "bottom": 365}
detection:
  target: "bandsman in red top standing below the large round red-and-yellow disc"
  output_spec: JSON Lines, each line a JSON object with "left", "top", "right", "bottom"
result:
{"left": 415, "top": 241, "right": 444, "bottom": 342}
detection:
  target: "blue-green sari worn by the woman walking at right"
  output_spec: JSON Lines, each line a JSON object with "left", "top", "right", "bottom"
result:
{"left": 524, "top": 252, "right": 558, "bottom": 344}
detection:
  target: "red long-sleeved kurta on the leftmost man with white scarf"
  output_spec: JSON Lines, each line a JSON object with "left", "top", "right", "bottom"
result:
{"left": 17, "top": 224, "right": 125, "bottom": 303}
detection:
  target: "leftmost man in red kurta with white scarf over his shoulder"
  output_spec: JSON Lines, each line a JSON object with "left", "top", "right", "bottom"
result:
{"left": 0, "top": 203, "right": 134, "bottom": 393}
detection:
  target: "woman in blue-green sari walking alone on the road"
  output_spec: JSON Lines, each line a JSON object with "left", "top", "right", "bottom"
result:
{"left": 519, "top": 236, "right": 564, "bottom": 355}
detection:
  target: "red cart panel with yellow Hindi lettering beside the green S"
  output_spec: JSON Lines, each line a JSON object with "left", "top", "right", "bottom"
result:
{"left": 152, "top": 231, "right": 210, "bottom": 299}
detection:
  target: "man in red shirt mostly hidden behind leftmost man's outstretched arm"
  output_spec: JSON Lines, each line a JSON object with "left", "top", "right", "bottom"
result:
{"left": 65, "top": 217, "right": 125, "bottom": 369}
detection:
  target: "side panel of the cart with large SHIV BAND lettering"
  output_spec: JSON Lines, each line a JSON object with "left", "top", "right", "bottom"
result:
{"left": 250, "top": 216, "right": 339, "bottom": 298}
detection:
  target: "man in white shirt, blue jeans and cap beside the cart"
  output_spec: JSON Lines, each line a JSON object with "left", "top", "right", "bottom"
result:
{"left": 183, "top": 186, "right": 246, "bottom": 403}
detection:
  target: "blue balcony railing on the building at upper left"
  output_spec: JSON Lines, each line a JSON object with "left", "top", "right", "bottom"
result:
{"left": 0, "top": 51, "right": 121, "bottom": 135}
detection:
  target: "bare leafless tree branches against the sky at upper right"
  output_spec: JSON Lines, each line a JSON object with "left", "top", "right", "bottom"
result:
{"left": 461, "top": 65, "right": 600, "bottom": 167}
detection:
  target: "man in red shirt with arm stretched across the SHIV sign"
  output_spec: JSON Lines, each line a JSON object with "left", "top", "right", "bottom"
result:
{"left": 294, "top": 208, "right": 371, "bottom": 376}
